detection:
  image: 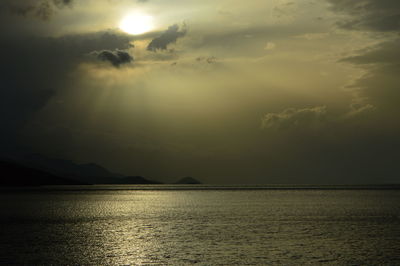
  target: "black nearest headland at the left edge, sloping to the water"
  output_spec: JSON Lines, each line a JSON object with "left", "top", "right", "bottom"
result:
{"left": 0, "top": 161, "right": 86, "bottom": 186}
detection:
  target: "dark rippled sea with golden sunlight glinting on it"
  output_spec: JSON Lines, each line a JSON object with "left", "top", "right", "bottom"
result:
{"left": 0, "top": 185, "right": 400, "bottom": 265}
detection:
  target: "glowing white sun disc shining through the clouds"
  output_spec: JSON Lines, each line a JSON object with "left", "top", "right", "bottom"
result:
{"left": 119, "top": 13, "right": 153, "bottom": 35}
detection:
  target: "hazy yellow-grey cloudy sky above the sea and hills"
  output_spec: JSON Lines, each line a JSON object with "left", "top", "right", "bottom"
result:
{"left": 0, "top": 0, "right": 400, "bottom": 184}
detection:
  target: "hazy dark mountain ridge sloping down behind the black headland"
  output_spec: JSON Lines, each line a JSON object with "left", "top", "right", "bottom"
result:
{"left": 1, "top": 154, "right": 160, "bottom": 184}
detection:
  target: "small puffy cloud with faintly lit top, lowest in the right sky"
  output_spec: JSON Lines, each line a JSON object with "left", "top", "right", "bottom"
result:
{"left": 261, "top": 106, "right": 327, "bottom": 130}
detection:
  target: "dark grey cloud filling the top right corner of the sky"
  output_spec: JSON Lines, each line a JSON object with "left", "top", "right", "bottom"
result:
{"left": 328, "top": 0, "right": 400, "bottom": 31}
